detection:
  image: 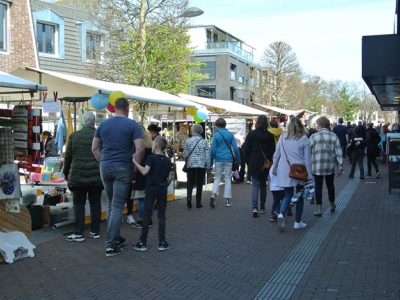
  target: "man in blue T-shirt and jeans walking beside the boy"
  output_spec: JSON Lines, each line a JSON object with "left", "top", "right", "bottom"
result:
{"left": 92, "top": 98, "right": 144, "bottom": 256}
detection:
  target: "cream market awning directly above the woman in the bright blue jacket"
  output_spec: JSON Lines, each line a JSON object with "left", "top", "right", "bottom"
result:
{"left": 178, "top": 94, "right": 266, "bottom": 117}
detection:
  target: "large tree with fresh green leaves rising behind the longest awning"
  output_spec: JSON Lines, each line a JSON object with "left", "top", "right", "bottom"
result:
{"left": 55, "top": 0, "right": 207, "bottom": 125}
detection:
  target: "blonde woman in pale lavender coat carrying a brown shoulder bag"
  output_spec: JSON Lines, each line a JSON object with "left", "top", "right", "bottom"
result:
{"left": 271, "top": 118, "right": 313, "bottom": 232}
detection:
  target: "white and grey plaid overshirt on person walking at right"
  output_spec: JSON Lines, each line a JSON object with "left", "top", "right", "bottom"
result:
{"left": 309, "top": 128, "right": 343, "bottom": 175}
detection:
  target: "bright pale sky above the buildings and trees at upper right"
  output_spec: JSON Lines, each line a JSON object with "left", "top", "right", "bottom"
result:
{"left": 189, "top": 0, "right": 396, "bottom": 82}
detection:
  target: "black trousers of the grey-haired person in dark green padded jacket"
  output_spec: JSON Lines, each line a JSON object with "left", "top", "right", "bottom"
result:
{"left": 72, "top": 186, "right": 103, "bottom": 235}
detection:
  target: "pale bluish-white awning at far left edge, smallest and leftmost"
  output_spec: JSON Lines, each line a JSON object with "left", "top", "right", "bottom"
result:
{"left": 0, "top": 71, "right": 47, "bottom": 94}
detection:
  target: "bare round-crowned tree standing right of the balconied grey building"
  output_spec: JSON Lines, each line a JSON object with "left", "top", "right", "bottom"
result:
{"left": 260, "top": 41, "right": 300, "bottom": 107}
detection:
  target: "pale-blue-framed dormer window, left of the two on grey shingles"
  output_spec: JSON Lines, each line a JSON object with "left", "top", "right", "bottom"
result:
{"left": 32, "top": 9, "right": 65, "bottom": 58}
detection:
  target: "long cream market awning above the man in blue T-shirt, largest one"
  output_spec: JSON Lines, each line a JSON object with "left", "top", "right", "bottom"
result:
{"left": 13, "top": 67, "right": 198, "bottom": 111}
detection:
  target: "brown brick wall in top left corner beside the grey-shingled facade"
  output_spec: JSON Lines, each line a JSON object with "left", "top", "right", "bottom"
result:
{"left": 0, "top": 0, "right": 38, "bottom": 73}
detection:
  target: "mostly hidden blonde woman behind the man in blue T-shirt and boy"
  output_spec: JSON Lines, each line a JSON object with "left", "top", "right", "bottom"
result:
{"left": 126, "top": 125, "right": 153, "bottom": 228}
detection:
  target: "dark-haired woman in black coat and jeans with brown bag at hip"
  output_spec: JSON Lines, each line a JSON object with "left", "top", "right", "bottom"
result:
{"left": 244, "top": 115, "right": 275, "bottom": 217}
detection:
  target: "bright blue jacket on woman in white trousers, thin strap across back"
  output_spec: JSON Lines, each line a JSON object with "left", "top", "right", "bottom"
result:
{"left": 211, "top": 128, "right": 241, "bottom": 164}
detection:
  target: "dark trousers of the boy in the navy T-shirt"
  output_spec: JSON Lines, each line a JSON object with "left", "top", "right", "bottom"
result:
{"left": 140, "top": 193, "right": 167, "bottom": 245}
